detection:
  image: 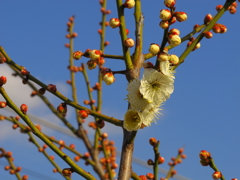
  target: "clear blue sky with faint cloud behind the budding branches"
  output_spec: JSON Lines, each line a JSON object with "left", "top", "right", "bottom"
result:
{"left": 0, "top": 0, "right": 240, "bottom": 180}
